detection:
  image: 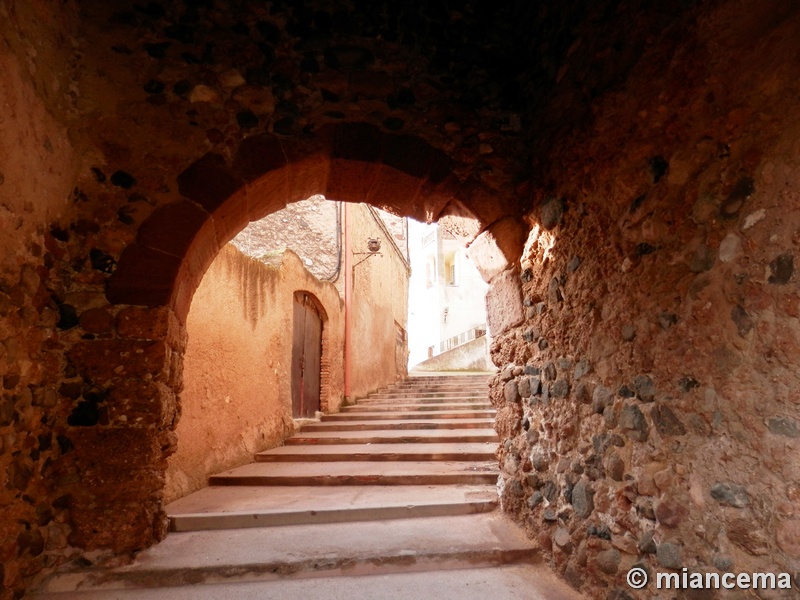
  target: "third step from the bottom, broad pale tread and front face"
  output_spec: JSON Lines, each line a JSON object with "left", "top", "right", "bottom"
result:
{"left": 166, "top": 485, "right": 497, "bottom": 531}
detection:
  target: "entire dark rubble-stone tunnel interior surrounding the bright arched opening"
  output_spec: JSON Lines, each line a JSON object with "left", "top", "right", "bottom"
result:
{"left": 0, "top": 0, "right": 800, "bottom": 600}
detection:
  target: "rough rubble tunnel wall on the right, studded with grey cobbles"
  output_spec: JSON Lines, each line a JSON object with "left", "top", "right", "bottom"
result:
{"left": 492, "top": 3, "right": 800, "bottom": 598}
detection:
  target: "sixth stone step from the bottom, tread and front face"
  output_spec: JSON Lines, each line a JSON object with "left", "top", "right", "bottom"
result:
{"left": 285, "top": 429, "right": 499, "bottom": 446}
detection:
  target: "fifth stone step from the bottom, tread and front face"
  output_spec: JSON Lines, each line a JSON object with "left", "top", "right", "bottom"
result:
{"left": 255, "top": 440, "right": 498, "bottom": 463}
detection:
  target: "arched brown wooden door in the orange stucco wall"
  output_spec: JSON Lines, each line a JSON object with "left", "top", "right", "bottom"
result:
{"left": 292, "top": 292, "right": 322, "bottom": 418}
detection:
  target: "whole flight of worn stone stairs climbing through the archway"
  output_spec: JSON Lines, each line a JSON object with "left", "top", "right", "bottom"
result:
{"left": 33, "top": 375, "right": 579, "bottom": 600}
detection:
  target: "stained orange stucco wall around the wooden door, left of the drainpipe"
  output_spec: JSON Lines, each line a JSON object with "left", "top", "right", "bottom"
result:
{"left": 165, "top": 244, "right": 344, "bottom": 502}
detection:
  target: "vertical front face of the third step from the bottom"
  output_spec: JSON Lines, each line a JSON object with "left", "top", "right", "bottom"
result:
{"left": 170, "top": 500, "right": 497, "bottom": 532}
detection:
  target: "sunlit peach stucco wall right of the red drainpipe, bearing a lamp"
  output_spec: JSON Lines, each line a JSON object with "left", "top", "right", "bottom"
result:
{"left": 345, "top": 204, "right": 409, "bottom": 399}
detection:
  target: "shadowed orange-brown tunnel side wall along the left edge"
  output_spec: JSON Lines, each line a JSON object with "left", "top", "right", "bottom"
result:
{"left": 0, "top": 0, "right": 81, "bottom": 598}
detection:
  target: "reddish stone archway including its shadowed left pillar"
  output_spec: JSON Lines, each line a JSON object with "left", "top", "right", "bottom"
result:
{"left": 59, "top": 123, "right": 522, "bottom": 553}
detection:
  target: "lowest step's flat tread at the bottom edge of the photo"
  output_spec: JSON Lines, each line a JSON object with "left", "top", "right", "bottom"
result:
{"left": 31, "top": 564, "right": 585, "bottom": 600}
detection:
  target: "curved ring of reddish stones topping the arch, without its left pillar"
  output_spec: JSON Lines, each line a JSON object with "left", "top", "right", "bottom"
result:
{"left": 107, "top": 123, "right": 522, "bottom": 319}
